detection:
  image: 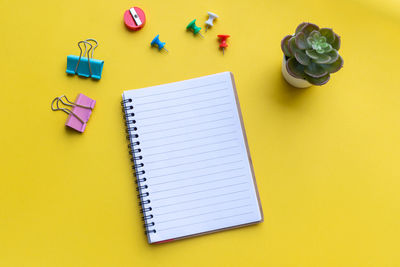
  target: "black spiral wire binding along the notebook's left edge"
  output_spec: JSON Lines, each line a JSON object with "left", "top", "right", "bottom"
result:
{"left": 121, "top": 98, "right": 156, "bottom": 234}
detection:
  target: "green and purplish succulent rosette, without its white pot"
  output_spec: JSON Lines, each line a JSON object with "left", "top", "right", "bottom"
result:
{"left": 281, "top": 22, "right": 343, "bottom": 85}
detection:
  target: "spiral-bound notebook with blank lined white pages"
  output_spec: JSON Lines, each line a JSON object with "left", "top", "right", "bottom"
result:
{"left": 122, "top": 72, "right": 263, "bottom": 243}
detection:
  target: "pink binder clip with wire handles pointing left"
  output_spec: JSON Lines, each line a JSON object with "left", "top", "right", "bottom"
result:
{"left": 51, "top": 94, "right": 96, "bottom": 133}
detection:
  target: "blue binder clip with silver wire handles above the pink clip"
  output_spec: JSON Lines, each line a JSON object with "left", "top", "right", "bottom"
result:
{"left": 67, "top": 39, "right": 104, "bottom": 80}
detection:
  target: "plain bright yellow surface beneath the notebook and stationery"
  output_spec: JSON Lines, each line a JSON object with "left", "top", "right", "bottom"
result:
{"left": 0, "top": 0, "right": 400, "bottom": 267}
